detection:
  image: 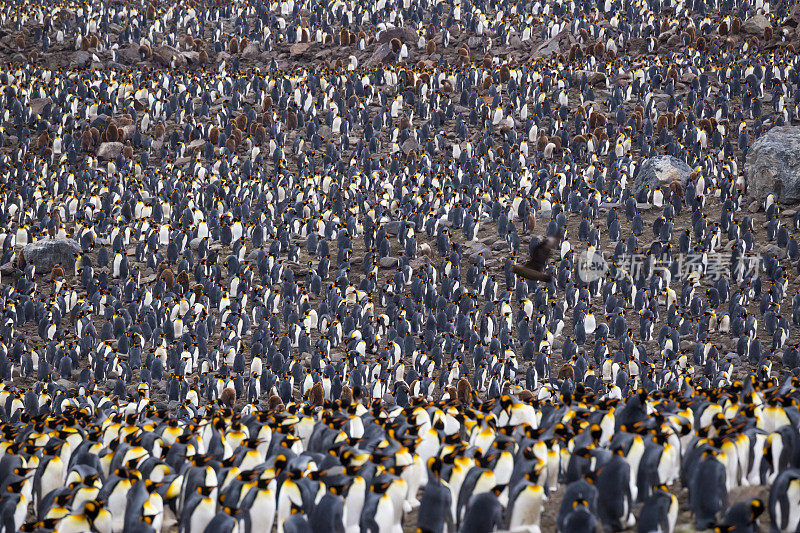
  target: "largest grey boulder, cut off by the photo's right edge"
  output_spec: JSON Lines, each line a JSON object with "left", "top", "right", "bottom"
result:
{"left": 745, "top": 126, "right": 800, "bottom": 202}
